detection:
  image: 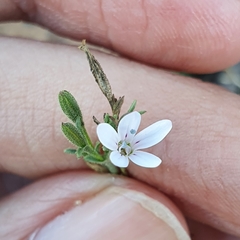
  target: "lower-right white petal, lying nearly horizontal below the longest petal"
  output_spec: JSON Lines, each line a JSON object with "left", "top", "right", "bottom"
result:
{"left": 129, "top": 151, "right": 162, "bottom": 168}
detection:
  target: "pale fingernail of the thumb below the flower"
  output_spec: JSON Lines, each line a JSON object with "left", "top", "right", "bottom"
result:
{"left": 30, "top": 187, "right": 190, "bottom": 240}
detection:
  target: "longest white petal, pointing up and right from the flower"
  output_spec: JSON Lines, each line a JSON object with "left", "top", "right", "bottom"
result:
{"left": 132, "top": 120, "right": 172, "bottom": 150}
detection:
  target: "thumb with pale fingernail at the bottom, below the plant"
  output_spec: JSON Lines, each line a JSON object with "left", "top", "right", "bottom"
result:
{"left": 0, "top": 172, "right": 190, "bottom": 240}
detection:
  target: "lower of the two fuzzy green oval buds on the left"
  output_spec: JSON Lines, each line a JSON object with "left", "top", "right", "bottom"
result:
{"left": 62, "top": 123, "right": 86, "bottom": 147}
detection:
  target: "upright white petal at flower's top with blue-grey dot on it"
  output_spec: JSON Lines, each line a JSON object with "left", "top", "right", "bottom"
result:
{"left": 118, "top": 111, "right": 141, "bottom": 142}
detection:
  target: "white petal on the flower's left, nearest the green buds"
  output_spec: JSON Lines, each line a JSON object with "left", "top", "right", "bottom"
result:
{"left": 97, "top": 123, "right": 120, "bottom": 151}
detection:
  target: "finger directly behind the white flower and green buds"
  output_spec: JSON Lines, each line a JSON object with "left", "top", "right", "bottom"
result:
{"left": 0, "top": 39, "right": 240, "bottom": 236}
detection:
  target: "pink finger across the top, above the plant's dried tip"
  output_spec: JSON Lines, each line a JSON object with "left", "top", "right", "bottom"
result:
{"left": 0, "top": 0, "right": 240, "bottom": 73}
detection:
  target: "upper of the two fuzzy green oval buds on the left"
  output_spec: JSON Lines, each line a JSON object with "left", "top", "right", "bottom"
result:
{"left": 58, "top": 90, "right": 83, "bottom": 124}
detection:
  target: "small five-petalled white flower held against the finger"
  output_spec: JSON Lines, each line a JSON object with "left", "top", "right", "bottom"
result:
{"left": 97, "top": 112, "right": 172, "bottom": 168}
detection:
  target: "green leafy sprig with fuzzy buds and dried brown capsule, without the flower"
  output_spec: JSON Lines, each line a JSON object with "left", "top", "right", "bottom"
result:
{"left": 58, "top": 40, "right": 145, "bottom": 175}
